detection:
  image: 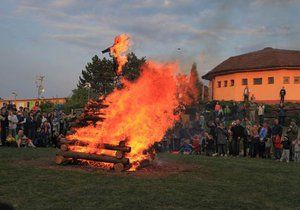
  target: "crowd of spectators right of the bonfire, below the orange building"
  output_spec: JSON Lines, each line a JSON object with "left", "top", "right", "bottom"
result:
{"left": 160, "top": 101, "right": 300, "bottom": 162}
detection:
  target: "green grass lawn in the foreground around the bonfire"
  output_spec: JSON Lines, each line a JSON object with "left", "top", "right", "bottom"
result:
{"left": 0, "top": 147, "right": 300, "bottom": 209}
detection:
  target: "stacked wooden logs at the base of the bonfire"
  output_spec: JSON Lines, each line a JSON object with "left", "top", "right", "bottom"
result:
{"left": 55, "top": 138, "right": 131, "bottom": 172}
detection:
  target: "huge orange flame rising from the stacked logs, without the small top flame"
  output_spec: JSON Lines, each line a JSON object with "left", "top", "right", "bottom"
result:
{"left": 68, "top": 62, "right": 184, "bottom": 169}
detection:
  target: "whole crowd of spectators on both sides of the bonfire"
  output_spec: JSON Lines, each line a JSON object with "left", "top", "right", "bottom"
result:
{"left": 0, "top": 94, "right": 300, "bottom": 162}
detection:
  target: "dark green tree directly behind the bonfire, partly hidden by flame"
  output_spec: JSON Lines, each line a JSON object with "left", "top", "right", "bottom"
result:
{"left": 64, "top": 53, "right": 146, "bottom": 112}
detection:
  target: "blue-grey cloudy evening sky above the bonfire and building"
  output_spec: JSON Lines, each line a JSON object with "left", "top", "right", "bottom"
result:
{"left": 0, "top": 0, "right": 300, "bottom": 98}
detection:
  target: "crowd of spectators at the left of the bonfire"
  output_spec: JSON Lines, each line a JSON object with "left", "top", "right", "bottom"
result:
{"left": 0, "top": 102, "right": 68, "bottom": 147}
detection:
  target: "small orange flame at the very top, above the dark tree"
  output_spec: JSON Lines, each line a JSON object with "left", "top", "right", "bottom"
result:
{"left": 110, "top": 34, "right": 129, "bottom": 75}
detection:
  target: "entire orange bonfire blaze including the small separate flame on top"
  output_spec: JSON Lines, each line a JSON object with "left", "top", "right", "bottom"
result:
{"left": 55, "top": 35, "right": 197, "bottom": 170}
